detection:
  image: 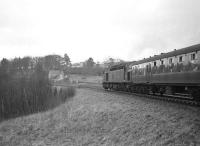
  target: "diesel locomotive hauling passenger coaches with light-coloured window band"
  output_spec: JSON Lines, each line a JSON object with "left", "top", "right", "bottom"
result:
{"left": 102, "top": 44, "right": 200, "bottom": 101}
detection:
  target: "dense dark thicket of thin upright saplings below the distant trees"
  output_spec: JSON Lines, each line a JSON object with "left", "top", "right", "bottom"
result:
{"left": 0, "top": 69, "right": 75, "bottom": 121}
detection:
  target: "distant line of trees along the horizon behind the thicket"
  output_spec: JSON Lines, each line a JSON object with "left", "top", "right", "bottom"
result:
{"left": 0, "top": 53, "right": 124, "bottom": 75}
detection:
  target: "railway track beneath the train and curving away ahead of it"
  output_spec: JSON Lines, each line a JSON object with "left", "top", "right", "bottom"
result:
{"left": 54, "top": 84, "right": 200, "bottom": 106}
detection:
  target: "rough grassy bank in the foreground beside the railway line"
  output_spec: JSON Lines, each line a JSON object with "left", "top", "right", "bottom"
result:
{"left": 0, "top": 89, "right": 200, "bottom": 146}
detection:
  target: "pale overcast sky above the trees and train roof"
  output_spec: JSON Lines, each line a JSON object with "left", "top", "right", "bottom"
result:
{"left": 0, "top": 0, "right": 200, "bottom": 62}
